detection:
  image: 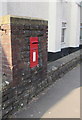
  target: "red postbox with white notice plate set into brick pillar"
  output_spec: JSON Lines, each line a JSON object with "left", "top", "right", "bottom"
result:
{"left": 30, "top": 37, "right": 38, "bottom": 68}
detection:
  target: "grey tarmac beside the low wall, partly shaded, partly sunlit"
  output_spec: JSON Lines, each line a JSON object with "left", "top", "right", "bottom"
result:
{"left": 13, "top": 65, "right": 80, "bottom": 118}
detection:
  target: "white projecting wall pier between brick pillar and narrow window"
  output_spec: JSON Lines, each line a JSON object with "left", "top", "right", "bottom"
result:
{"left": 48, "top": 1, "right": 62, "bottom": 52}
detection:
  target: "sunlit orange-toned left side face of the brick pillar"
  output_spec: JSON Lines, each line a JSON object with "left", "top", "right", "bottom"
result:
{"left": 1, "top": 24, "right": 12, "bottom": 81}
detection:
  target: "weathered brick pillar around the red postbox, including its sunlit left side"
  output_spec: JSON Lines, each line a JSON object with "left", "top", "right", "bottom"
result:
{"left": 1, "top": 17, "right": 48, "bottom": 117}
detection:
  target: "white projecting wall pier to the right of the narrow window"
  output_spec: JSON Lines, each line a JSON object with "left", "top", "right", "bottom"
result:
{"left": 68, "top": 2, "right": 80, "bottom": 47}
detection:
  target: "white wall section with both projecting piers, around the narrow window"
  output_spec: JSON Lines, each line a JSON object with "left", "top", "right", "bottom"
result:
{"left": 48, "top": 1, "right": 80, "bottom": 52}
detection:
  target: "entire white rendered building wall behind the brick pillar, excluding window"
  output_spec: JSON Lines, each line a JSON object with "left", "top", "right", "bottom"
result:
{"left": 0, "top": 0, "right": 82, "bottom": 52}
